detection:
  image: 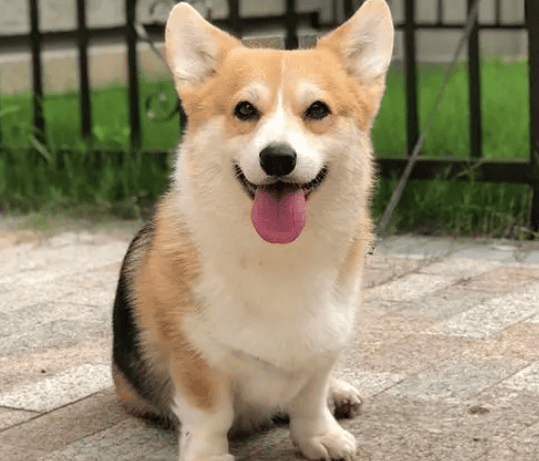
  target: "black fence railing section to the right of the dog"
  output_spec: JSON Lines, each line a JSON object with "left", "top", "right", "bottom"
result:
{"left": 377, "top": 0, "right": 539, "bottom": 231}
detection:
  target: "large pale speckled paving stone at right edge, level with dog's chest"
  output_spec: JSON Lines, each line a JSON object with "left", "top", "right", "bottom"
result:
{"left": 432, "top": 284, "right": 539, "bottom": 338}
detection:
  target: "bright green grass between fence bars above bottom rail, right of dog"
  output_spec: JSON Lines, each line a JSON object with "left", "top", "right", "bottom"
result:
{"left": 373, "top": 61, "right": 529, "bottom": 159}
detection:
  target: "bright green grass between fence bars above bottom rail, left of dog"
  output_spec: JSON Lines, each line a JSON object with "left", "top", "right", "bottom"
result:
{"left": 0, "top": 80, "right": 179, "bottom": 150}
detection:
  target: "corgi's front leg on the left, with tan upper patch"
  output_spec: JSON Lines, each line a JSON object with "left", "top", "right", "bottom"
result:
{"left": 171, "top": 357, "right": 234, "bottom": 461}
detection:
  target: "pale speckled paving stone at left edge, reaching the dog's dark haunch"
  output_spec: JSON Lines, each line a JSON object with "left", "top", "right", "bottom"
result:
{"left": 0, "top": 363, "right": 112, "bottom": 412}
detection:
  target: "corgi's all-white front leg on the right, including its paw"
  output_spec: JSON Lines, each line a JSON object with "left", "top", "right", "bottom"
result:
{"left": 289, "top": 368, "right": 356, "bottom": 461}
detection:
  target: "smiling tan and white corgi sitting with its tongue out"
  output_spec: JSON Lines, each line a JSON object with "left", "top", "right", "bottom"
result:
{"left": 112, "top": 0, "right": 393, "bottom": 461}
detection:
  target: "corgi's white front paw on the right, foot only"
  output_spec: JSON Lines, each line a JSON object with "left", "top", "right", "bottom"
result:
{"left": 293, "top": 426, "right": 356, "bottom": 461}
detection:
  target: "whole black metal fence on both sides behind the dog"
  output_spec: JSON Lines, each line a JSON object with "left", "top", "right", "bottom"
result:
{"left": 0, "top": 0, "right": 539, "bottom": 230}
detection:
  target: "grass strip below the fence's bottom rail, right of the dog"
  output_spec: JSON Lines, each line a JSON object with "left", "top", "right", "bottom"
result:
{"left": 372, "top": 172, "right": 537, "bottom": 239}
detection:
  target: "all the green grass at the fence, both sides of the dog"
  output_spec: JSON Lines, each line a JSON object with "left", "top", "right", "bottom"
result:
{"left": 0, "top": 61, "right": 530, "bottom": 238}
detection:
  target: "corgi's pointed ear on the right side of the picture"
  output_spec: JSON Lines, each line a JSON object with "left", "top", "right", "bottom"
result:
{"left": 318, "top": 0, "right": 393, "bottom": 85}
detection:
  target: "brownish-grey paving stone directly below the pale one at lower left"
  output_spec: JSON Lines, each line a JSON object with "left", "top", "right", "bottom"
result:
{"left": 0, "top": 389, "right": 130, "bottom": 452}
